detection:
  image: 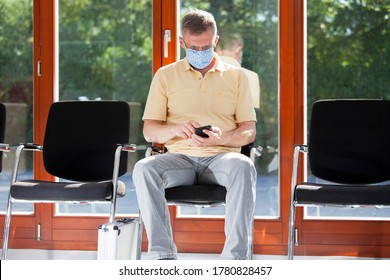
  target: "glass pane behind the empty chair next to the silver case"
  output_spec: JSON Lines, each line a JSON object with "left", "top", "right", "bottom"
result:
{"left": 57, "top": 0, "right": 153, "bottom": 216}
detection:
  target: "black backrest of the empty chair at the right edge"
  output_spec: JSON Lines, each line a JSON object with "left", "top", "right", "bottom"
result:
{"left": 308, "top": 99, "right": 390, "bottom": 183}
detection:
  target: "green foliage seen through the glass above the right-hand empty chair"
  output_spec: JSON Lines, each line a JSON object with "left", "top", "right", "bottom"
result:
{"left": 307, "top": 0, "right": 390, "bottom": 112}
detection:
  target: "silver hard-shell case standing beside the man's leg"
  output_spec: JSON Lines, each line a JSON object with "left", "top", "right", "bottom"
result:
{"left": 97, "top": 218, "right": 142, "bottom": 260}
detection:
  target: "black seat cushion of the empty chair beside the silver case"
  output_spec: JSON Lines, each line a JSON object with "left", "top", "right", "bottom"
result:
{"left": 10, "top": 180, "right": 126, "bottom": 201}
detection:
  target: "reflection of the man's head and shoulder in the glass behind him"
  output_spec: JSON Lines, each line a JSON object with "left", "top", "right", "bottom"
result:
{"left": 215, "top": 29, "right": 260, "bottom": 108}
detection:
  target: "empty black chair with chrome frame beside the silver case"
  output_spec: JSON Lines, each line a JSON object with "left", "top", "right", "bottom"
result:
{"left": 2, "top": 101, "right": 136, "bottom": 259}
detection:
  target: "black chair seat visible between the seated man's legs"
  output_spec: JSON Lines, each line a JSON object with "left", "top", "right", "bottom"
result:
{"left": 165, "top": 185, "right": 226, "bottom": 206}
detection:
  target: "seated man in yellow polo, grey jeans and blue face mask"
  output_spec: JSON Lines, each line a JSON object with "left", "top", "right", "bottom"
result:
{"left": 133, "top": 10, "right": 256, "bottom": 259}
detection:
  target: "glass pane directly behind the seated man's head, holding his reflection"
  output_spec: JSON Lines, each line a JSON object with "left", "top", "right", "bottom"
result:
{"left": 179, "top": 0, "right": 280, "bottom": 219}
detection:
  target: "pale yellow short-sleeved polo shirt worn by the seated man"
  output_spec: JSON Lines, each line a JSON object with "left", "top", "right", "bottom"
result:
{"left": 143, "top": 54, "right": 256, "bottom": 157}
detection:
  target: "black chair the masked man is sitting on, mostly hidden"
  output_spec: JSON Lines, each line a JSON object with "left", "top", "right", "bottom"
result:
{"left": 146, "top": 144, "right": 263, "bottom": 257}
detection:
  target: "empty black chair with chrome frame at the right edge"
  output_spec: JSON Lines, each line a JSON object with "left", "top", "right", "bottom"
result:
{"left": 288, "top": 100, "right": 390, "bottom": 260}
